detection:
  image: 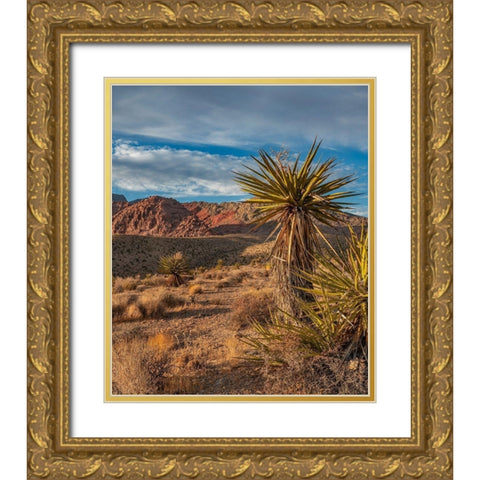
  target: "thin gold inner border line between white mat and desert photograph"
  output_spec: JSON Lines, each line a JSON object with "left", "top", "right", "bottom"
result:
{"left": 104, "top": 77, "right": 376, "bottom": 402}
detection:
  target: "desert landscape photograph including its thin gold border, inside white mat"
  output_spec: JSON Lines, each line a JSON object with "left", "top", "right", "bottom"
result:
{"left": 105, "top": 79, "right": 374, "bottom": 400}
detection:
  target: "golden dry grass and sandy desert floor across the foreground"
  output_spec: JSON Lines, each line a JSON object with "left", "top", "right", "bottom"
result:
{"left": 112, "top": 265, "right": 367, "bottom": 395}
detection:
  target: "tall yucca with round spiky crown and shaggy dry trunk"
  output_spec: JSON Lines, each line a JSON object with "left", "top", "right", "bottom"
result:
{"left": 235, "top": 139, "right": 355, "bottom": 314}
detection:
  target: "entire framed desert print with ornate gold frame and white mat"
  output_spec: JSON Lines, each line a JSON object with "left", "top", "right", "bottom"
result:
{"left": 28, "top": 0, "right": 452, "bottom": 479}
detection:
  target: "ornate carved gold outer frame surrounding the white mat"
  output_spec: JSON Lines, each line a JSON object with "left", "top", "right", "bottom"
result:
{"left": 28, "top": 0, "right": 453, "bottom": 479}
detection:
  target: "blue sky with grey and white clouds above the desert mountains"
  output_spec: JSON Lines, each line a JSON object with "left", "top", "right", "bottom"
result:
{"left": 112, "top": 85, "right": 368, "bottom": 215}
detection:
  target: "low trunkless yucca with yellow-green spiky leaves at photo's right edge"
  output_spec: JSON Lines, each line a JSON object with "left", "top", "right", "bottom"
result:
{"left": 243, "top": 226, "right": 368, "bottom": 364}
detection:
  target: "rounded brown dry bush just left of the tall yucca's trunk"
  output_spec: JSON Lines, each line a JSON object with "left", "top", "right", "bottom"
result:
{"left": 230, "top": 288, "right": 274, "bottom": 327}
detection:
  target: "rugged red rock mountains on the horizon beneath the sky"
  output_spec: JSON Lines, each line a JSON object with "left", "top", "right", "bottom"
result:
{"left": 112, "top": 194, "right": 366, "bottom": 238}
